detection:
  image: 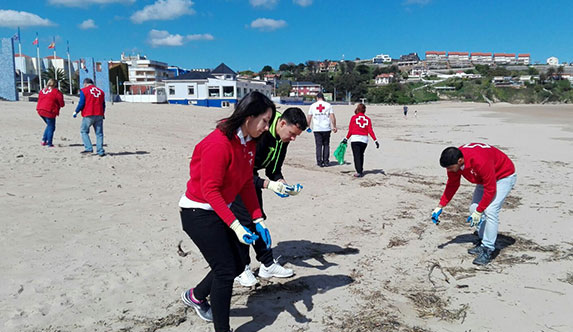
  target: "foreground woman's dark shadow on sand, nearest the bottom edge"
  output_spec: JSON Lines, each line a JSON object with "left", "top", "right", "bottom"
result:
{"left": 231, "top": 274, "right": 354, "bottom": 332}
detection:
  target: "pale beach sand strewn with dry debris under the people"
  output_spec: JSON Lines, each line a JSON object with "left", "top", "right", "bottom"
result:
{"left": 0, "top": 101, "right": 573, "bottom": 332}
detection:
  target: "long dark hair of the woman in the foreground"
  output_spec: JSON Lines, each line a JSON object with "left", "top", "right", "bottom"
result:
{"left": 217, "top": 91, "right": 277, "bottom": 139}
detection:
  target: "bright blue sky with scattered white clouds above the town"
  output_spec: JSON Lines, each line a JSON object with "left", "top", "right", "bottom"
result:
{"left": 0, "top": 0, "right": 573, "bottom": 71}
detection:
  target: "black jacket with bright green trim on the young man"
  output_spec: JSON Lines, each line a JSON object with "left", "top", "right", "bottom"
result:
{"left": 253, "top": 112, "right": 288, "bottom": 189}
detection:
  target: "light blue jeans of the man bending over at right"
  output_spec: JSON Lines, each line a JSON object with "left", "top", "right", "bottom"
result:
{"left": 470, "top": 173, "right": 517, "bottom": 250}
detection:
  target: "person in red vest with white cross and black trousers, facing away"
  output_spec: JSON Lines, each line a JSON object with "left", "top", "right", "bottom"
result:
{"left": 342, "top": 104, "right": 380, "bottom": 178}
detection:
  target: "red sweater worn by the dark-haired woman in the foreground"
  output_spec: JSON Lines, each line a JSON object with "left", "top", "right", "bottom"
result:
{"left": 185, "top": 129, "right": 262, "bottom": 225}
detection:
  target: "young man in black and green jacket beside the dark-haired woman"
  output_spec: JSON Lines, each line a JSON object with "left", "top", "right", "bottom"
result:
{"left": 231, "top": 107, "right": 308, "bottom": 287}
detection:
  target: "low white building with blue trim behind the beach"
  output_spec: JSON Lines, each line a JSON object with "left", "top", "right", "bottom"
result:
{"left": 164, "top": 63, "right": 272, "bottom": 107}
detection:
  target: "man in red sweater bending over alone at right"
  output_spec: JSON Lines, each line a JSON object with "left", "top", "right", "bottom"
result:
{"left": 432, "top": 143, "right": 517, "bottom": 265}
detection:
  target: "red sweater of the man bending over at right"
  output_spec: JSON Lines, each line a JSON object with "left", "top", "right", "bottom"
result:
{"left": 440, "top": 143, "right": 515, "bottom": 212}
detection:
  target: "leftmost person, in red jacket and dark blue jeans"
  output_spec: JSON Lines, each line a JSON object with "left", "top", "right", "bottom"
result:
{"left": 36, "top": 79, "right": 64, "bottom": 147}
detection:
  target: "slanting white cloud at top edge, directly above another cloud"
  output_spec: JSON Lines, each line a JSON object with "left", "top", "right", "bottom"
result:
{"left": 131, "top": 0, "right": 195, "bottom": 23}
